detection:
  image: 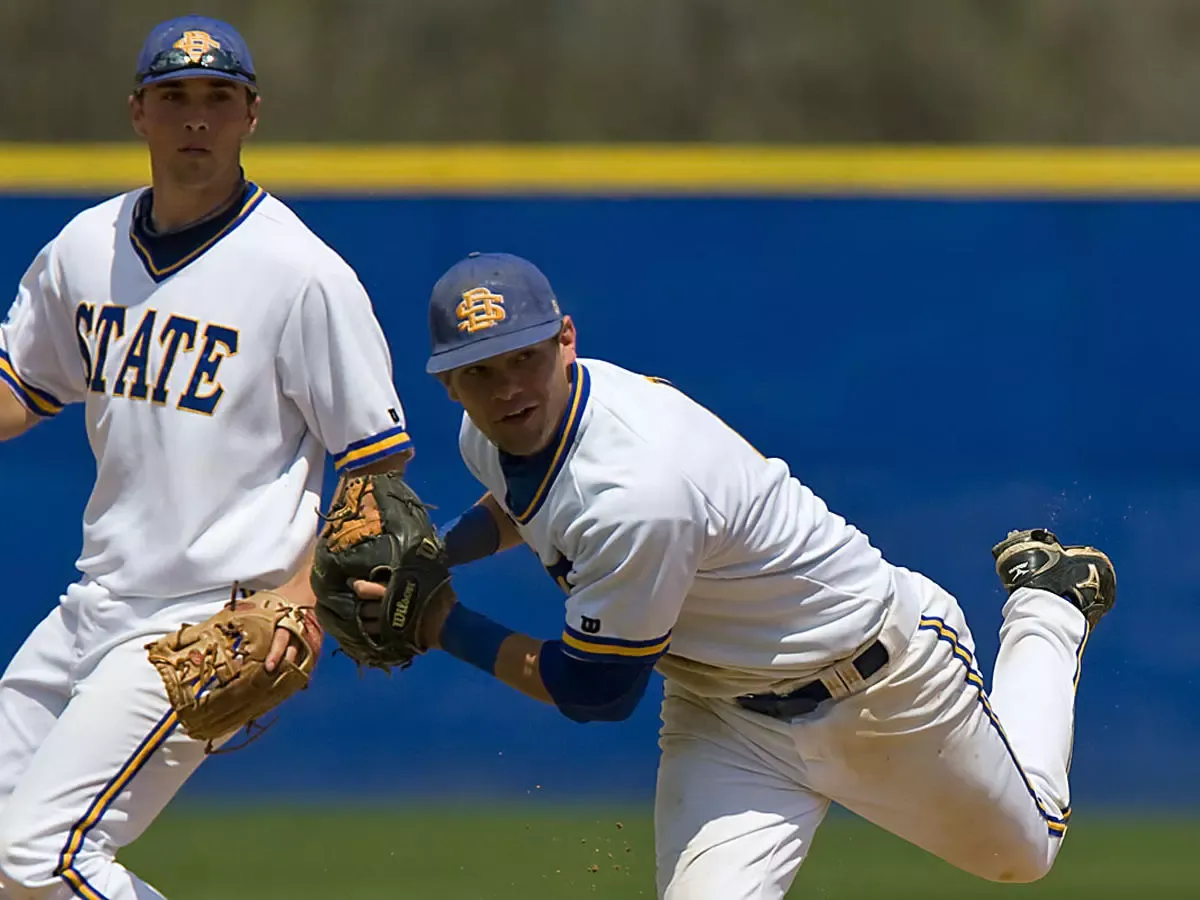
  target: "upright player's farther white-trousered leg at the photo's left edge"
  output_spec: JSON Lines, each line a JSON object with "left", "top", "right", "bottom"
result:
{"left": 0, "top": 606, "right": 74, "bottom": 811}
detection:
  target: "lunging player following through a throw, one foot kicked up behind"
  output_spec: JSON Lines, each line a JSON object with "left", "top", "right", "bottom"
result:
{"left": 355, "top": 253, "right": 1116, "bottom": 900}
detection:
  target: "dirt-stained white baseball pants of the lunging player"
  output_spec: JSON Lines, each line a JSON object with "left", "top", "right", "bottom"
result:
{"left": 655, "top": 570, "right": 1087, "bottom": 900}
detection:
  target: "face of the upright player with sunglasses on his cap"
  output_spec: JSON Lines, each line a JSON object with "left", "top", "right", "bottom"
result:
{"left": 130, "top": 78, "right": 259, "bottom": 186}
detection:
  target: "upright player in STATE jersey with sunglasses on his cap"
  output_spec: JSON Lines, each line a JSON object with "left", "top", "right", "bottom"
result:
{"left": 0, "top": 16, "right": 410, "bottom": 900}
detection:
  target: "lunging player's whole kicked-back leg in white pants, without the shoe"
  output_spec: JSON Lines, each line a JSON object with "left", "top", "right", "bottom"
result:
{"left": 794, "top": 540, "right": 1111, "bottom": 882}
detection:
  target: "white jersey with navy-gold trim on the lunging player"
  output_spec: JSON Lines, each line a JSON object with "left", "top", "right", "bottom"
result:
{"left": 460, "top": 360, "right": 893, "bottom": 696}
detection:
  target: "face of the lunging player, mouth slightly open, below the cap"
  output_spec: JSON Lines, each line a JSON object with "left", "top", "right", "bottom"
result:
{"left": 445, "top": 316, "right": 575, "bottom": 456}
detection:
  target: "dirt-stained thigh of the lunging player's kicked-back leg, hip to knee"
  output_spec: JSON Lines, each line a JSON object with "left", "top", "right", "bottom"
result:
{"left": 793, "top": 580, "right": 1062, "bottom": 882}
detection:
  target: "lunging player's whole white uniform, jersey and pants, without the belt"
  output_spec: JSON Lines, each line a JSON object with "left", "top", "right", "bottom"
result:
{"left": 460, "top": 360, "right": 1087, "bottom": 900}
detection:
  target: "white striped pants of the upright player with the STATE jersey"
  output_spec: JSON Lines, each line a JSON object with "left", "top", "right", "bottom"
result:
{"left": 0, "top": 583, "right": 228, "bottom": 900}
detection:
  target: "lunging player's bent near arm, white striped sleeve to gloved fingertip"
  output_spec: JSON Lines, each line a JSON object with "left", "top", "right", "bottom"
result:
{"left": 369, "top": 479, "right": 704, "bottom": 721}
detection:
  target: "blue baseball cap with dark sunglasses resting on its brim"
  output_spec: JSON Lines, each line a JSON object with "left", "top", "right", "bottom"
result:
{"left": 133, "top": 16, "right": 258, "bottom": 90}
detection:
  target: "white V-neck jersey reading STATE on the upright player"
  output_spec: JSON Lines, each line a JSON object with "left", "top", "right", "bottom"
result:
{"left": 0, "top": 185, "right": 408, "bottom": 598}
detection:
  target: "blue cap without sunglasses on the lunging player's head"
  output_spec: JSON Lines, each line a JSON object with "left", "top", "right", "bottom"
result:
{"left": 425, "top": 253, "right": 563, "bottom": 374}
